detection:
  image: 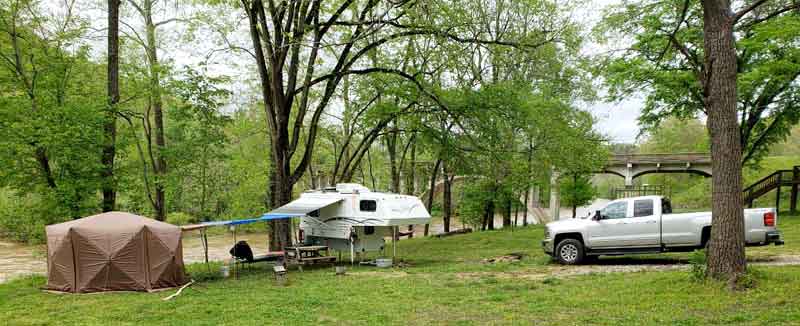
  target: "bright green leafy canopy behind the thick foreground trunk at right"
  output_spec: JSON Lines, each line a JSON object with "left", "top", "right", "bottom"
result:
{"left": 595, "top": 0, "right": 800, "bottom": 165}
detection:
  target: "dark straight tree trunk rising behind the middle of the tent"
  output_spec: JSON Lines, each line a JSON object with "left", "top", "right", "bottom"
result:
{"left": 100, "top": 0, "right": 120, "bottom": 212}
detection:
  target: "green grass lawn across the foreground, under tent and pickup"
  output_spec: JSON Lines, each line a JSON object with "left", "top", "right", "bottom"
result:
{"left": 0, "top": 214, "right": 800, "bottom": 325}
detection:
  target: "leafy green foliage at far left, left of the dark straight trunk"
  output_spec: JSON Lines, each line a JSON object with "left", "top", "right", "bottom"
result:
{"left": 0, "top": 1, "right": 105, "bottom": 241}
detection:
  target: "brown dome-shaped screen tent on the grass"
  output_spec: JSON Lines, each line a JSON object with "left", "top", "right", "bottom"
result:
{"left": 45, "top": 212, "right": 186, "bottom": 293}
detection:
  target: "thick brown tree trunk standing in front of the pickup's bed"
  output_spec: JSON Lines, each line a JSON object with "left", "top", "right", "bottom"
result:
{"left": 702, "top": 0, "right": 746, "bottom": 281}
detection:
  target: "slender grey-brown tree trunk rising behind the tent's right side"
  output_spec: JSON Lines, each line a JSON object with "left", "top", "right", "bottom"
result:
{"left": 143, "top": 0, "right": 167, "bottom": 221}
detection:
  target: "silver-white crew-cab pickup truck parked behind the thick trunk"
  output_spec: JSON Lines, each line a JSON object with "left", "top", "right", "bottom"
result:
{"left": 542, "top": 196, "right": 783, "bottom": 264}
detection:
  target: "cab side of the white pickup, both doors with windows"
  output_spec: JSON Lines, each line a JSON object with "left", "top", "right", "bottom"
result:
{"left": 589, "top": 199, "right": 660, "bottom": 249}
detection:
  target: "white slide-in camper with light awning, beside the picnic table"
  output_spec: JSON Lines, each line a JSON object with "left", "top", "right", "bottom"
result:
{"left": 271, "top": 183, "right": 431, "bottom": 252}
